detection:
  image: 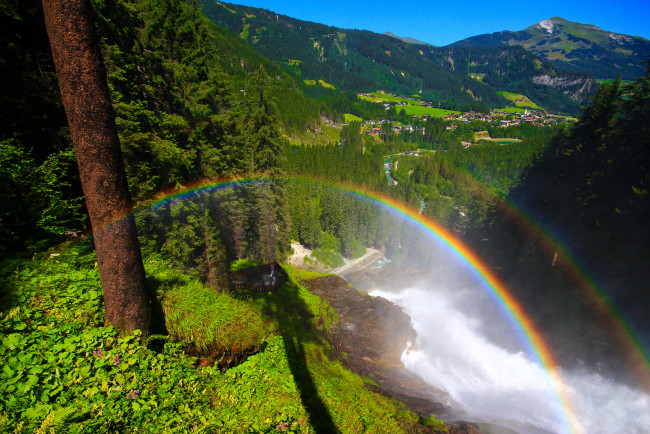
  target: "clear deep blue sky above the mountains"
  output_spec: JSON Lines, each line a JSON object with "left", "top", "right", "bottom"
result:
{"left": 221, "top": 0, "right": 650, "bottom": 46}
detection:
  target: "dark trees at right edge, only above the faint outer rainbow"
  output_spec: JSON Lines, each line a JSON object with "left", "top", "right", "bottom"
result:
{"left": 517, "top": 69, "right": 650, "bottom": 276}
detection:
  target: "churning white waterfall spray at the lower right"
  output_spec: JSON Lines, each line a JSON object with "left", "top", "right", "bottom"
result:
{"left": 370, "top": 288, "right": 650, "bottom": 434}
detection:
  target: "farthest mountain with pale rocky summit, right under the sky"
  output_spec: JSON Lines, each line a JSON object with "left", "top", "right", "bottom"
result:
{"left": 449, "top": 17, "right": 650, "bottom": 80}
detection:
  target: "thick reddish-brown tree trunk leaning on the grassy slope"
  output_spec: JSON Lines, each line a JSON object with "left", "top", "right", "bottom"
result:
{"left": 43, "top": 0, "right": 151, "bottom": 332}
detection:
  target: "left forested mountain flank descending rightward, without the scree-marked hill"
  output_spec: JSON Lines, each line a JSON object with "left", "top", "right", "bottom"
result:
{"left": 203, "top": 0, "right": 506, "bottom": 110}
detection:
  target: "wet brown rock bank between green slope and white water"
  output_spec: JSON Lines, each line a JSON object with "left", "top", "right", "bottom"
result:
{"left": 302, "top": 276, "right": 480, "bottom": 433}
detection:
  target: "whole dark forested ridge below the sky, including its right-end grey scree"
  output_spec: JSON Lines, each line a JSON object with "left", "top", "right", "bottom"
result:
{"left": 203, "top": 0, "right": 594, "bottom": 114}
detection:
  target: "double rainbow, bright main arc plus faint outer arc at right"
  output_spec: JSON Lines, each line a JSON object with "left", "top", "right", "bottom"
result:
{"left": 104, "top": 175, "right": 650, "bottom": 433}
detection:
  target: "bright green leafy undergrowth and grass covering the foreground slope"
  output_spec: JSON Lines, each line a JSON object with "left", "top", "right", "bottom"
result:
{"left": 0, "top": 249, "right": 440, "bottom": 433}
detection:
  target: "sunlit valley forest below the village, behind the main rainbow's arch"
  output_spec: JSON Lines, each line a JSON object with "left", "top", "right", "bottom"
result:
{"left": 285, "top": 115, "right": 555, "bottom": 266}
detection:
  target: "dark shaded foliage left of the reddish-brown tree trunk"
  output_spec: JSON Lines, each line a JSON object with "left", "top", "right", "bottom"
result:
{"left": 0, "top": 1, "right": 86, "bottom": 257}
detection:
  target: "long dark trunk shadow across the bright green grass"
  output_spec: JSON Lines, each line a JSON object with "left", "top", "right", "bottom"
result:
{"left": 252, "top": 274, "right": 339, "bottom": 433}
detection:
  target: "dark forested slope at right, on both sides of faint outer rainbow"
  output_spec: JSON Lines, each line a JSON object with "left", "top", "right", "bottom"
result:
{"left": 460, "top": 69, "right": 650, "bottom": 359}
